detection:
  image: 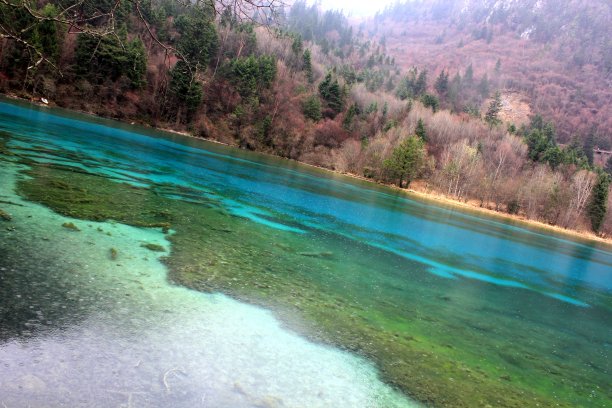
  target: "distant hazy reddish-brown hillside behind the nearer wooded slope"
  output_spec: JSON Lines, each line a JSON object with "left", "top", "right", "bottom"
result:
{"left": 363, "top": 0, "right": 612, "bottom": 149}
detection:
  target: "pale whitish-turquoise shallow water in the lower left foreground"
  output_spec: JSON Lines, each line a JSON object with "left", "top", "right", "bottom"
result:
{"left": 0, "top": 145, "right": 415, "bottom": 407}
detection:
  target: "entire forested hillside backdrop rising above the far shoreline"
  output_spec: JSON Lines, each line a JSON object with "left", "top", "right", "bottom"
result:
{"left": 0, "top": 0, "right": 612, "bottom": 235}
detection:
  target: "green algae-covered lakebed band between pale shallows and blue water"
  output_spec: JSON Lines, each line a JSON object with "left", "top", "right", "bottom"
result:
{"left": 19, "top": 166, "right": 612, "bottom": 407}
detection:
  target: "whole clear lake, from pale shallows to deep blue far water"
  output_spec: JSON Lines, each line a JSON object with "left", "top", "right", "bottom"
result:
{"left": 0, "top": 102, "right": 612, "bottom": 407}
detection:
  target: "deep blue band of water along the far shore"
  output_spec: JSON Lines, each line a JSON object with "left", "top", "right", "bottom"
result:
{"left": 0, "top": 99, "right": 612, "bottom": 306}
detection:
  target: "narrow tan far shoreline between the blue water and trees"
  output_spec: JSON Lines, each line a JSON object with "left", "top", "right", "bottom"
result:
{"left": 1, "top": 93, "right": 612, "bottom": 246}
